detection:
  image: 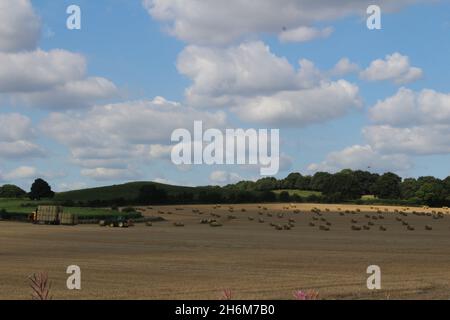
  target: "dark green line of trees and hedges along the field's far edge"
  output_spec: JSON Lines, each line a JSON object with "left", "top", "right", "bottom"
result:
{"left": 0, "top": 169, "right": 450, "bottom": 207}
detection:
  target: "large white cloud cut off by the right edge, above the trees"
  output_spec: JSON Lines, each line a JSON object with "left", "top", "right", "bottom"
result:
{"left": 363, "top": 88, "right": 450, "bottom": 155}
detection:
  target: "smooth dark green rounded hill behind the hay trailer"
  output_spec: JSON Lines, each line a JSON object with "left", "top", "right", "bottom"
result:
{"left": 54, "top": 182, "right": 197, "bottom": 201}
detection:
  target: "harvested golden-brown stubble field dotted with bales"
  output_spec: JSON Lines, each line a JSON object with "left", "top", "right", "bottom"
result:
{"left": 0, "top": 204, "right": 450, "bottom": 299}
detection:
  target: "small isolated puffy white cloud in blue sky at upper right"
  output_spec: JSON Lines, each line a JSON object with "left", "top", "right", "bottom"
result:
{"left": 361, "top": 52, "right": 423, "bottom": 85}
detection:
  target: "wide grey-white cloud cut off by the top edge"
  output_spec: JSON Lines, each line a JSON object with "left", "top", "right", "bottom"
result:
{"left": 143, "top": 0, "right": 426, "bottom": 45}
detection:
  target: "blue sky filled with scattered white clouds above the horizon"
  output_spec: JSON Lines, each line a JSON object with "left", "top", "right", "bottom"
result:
{"left": 0, "top": 0, "right": 450, "bottom": 191}
